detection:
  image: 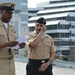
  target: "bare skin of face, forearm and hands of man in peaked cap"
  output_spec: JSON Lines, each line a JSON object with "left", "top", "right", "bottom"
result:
{"left": 0, "top": 10, "right": 25, "bottom": 48}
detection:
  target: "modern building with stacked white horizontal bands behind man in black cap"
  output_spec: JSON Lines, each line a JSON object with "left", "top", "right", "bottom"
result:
{"left": 28, "top": 0, "right": 75, "bottom": 61}
